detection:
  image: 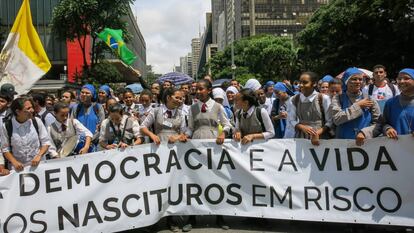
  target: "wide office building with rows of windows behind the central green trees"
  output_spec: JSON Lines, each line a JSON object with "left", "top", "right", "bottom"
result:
{"left": 217, "top": 0, "right": 329, "bottom": 50}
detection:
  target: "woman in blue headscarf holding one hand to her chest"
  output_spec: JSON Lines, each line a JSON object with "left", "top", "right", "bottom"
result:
{"left": 330, "top": 67, "right": 380, "bottom": 141}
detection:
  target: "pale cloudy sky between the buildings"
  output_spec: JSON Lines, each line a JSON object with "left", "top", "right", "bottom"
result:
{"left": 134, "top": 0, "right": 211, "bottom": 74}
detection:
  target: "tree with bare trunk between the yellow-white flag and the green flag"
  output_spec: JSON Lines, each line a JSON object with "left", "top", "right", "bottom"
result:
{"left": 52, "top": 0, "right": 134, "bottom": 72}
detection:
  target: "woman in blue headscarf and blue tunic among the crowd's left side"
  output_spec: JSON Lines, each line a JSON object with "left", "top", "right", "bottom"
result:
{"left": 72, "top": 84, "right": 105, "bottom": 145}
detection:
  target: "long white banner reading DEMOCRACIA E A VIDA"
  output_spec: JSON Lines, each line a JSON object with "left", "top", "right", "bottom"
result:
{"left": 0, "top": 136, "right": 414, "bottom": 232}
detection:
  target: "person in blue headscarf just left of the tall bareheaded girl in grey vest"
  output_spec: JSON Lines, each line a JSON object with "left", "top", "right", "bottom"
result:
{"left": 270, "top": 82, "right": 293, "bottom": 138}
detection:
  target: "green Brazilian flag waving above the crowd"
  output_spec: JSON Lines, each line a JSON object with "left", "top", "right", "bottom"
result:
{"left": 97, "top": 28, "right": 137, "bottom": 65}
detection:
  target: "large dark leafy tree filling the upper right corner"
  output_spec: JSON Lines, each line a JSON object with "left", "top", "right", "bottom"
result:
{"left": 298, "top": 0, "right": 414, "bottom": 75}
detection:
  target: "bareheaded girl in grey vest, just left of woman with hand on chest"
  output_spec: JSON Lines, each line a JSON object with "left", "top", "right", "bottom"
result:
{"left": 285, "top": 72, "right": 332, "bottom": 145}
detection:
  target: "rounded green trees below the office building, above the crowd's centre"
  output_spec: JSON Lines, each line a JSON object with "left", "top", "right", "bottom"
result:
{"left": 208, "top": 35, "right": 297, "bottom": 82}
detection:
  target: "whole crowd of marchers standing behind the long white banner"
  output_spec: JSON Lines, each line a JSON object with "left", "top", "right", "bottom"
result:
{"left": 0, "top": 65, "right": 414, "bottom": 231}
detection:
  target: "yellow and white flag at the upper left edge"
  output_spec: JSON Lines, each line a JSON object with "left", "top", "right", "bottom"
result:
{"left": 0, "top": 0, "right": 51, "bottom": 95}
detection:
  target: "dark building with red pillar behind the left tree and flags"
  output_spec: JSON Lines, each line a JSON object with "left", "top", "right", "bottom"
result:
{"left": 0, "top": 0, "right": 146, "bottom": 91}
